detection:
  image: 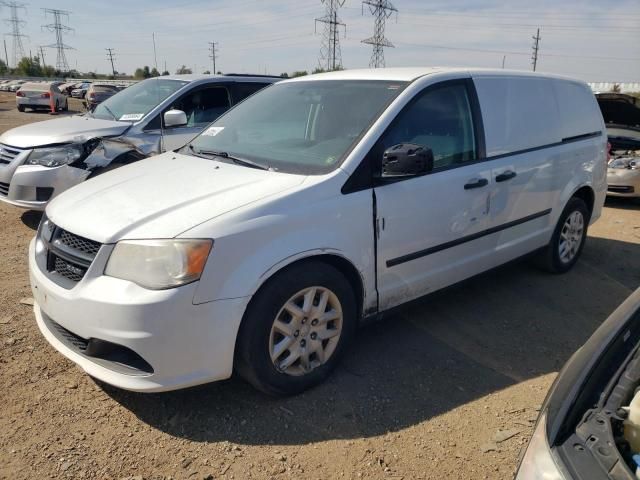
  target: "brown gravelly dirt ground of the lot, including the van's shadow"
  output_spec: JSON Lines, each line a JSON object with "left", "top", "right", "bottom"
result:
{"left": 0, "top": 94, "right": 640, "bottom": 480}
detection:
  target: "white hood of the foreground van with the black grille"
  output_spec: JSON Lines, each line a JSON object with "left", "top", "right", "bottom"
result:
{"left": 46, "top": 152, "right": 306, "bottom": 243}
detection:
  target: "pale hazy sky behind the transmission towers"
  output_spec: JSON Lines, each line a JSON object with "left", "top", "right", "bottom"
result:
{"left": 5, "top": 0, "right": 640, "bottom": 82}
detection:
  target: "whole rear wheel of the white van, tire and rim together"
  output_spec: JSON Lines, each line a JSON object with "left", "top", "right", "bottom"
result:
{"left": 537, "top": 197, "right": 591, "bottom": 273}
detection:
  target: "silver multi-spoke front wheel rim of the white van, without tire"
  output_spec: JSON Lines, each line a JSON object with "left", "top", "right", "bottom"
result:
{"left": 269, "top": 286, "right": 343, "bottom": 376}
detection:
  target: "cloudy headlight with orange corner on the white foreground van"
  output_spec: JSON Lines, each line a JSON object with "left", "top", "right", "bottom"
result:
{"left": 104, "top": 239, "right": 213, "bottom": 290}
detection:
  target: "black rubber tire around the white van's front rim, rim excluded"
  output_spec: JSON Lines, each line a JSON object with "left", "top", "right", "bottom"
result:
{"left": 235, "top": 260, "right": 358, "bottom": 395}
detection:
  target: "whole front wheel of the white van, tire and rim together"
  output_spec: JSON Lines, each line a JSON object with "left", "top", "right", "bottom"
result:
{"left": 235, "top": 261, "right": 357, "bottom": 395}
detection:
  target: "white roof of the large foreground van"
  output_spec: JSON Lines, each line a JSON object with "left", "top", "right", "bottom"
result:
{"left": 287, "top": 67, "right": 584, "bottom": 82}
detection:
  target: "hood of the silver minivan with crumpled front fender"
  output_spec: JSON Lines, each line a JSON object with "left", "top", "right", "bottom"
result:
{"left": 0, "top": 115, "right": 131, "bottom": 148}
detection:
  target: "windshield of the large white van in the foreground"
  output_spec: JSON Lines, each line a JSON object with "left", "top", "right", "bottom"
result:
{"left": 184, "top": 80, "right": 405, "bottom": 174}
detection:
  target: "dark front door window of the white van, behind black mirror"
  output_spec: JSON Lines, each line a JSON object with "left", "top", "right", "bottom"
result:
{"left": 380, "top": 85, "right": 477, "bottom": 170}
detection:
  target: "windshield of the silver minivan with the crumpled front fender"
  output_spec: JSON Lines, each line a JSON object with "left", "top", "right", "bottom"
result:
{"left": 91, "top": 78, "right": 189, "bottom": 122}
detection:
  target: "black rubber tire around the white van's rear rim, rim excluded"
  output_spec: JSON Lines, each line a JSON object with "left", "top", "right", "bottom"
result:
{"left": 536, "top": 197, "right": 591, "bottom": 273}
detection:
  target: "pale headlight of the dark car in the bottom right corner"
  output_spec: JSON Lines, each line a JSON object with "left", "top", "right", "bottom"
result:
{"left": 516, "top": 412, "right": 564, "bottom": 480}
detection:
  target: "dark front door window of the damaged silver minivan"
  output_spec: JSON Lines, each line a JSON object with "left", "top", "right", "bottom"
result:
{"left": 171, "top": 87, "right": 229, "bottom": 127}
